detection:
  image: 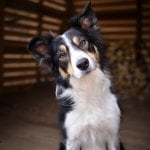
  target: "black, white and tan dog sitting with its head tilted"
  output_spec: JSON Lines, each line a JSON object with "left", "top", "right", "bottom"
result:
{"left": 28, "top": 2, "right": 123, "bottom": 150}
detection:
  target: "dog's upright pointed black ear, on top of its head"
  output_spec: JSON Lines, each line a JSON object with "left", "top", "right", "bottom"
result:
{"left": 71, "top": 2, "right": 98, "bottom": 30}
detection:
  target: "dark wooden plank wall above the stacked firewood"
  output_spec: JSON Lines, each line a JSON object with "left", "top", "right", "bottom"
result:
{"left": 74, "top": 0, "right": 150, "bottom": 41}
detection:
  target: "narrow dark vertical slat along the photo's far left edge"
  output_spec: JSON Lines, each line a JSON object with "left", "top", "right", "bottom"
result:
{"left": 0, "top": 0, "right": 5, "bottom": 94}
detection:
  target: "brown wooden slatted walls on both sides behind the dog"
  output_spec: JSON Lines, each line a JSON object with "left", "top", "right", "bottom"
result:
{"left": 0, "top": 0, "right": 150, "bottom": 93}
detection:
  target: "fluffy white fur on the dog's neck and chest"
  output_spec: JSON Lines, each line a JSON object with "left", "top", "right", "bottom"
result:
{"left": 65, "top": 69, "right": 120, "bottom": 150}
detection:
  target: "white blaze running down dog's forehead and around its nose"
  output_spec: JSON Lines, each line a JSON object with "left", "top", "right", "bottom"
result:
{"left": 62, "top": 33, "right": 95, "bottom": 78}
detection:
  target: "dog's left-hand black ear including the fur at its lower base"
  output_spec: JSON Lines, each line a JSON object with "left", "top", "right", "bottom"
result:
{"left": 27, "top": 32, "right": 54, "bottom": 69}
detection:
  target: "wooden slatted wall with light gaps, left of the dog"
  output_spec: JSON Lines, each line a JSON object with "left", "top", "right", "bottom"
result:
{"left": 0, "top": 0, "right": 66, "bottom": 93}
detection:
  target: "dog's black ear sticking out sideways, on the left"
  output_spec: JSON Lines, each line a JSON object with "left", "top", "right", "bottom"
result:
{"left": 27, "top": 33, "right": 53, "bottom": 61}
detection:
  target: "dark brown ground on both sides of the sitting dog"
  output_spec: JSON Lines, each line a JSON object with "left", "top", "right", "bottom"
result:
{"left": 0, "top": 84, "right": 150, "bottom": 150}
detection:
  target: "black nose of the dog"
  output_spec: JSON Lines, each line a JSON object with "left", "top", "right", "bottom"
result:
{"left": 77, "top": 58, "right": 89, "bottom": 70}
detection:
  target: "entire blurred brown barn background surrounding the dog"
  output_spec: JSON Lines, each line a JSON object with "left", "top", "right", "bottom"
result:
{"left": 0, "top": 0, "right": 150, "bottom": 150}
